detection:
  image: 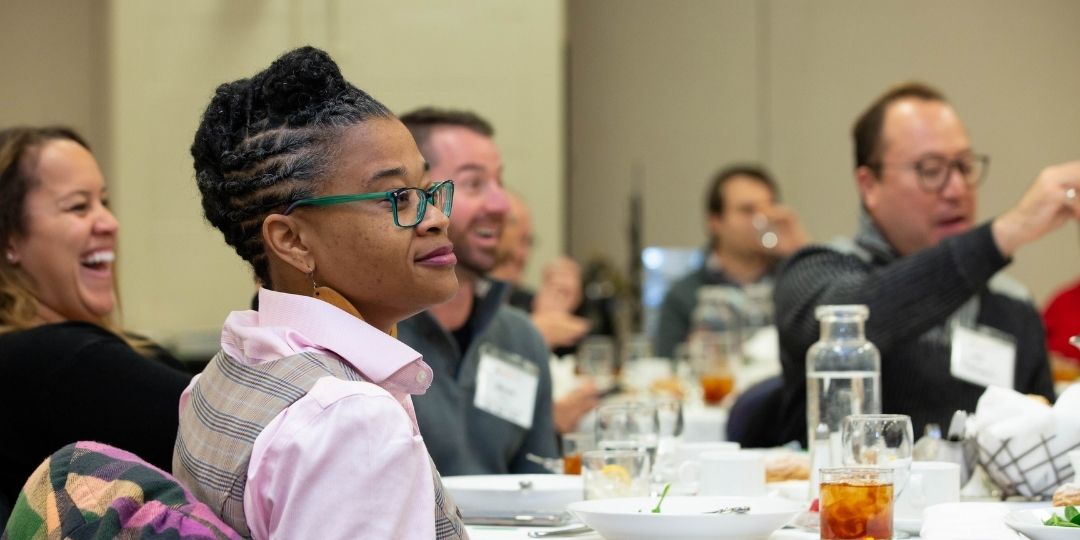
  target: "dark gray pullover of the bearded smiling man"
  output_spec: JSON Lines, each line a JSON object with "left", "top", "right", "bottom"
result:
{"left": 397, "top": 281, "right": 558, "bottom": 476}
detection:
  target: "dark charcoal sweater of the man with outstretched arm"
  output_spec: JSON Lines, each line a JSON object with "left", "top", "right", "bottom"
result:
{"left": 774, "top": 213, "right": 1054, "bottom": 444}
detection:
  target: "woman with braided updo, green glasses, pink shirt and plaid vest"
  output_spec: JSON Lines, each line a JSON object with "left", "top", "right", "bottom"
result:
{"left": 173, "top": 48, "right": 467, "bottom": 539}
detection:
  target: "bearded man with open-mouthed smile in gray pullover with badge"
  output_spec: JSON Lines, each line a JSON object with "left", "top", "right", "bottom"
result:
{"left": 399, "top": 108, "right": 558, "bottom": 475}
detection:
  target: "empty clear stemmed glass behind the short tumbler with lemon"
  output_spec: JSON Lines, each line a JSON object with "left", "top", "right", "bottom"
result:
{"left": 596, "top": 402, "right": 660, "bottom": 465}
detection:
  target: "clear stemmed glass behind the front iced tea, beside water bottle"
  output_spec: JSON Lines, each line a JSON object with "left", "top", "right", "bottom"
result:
{"left": 840, "top": 415, "right": 915, "bottom": 497}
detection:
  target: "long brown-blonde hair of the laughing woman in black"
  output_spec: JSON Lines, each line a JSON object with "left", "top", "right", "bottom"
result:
{"left": 0, "top": 126, "right": 151, "bottom": 353}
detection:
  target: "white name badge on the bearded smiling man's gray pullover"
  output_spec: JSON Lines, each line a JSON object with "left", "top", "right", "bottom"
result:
{"left": 473, "top": 345, "right": 540, "bottom": 429}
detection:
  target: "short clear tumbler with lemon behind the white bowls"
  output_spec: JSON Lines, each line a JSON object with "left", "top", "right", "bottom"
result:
{"left": 581, "top": 450, "right": 649, "bottom": 500}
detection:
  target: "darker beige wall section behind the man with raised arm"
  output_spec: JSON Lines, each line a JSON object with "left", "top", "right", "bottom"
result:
{"left": 567, "top": 0, "right": 1080, "bottom": 301}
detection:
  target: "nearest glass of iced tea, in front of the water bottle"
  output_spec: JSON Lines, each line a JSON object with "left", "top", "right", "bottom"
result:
{"left": 819, "top": 467, "right": 893, "bottom": 540}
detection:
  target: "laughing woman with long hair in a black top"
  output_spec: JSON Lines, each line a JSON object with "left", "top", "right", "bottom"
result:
{"left": 0, "top": 127, "right": 191, "bottom": 522}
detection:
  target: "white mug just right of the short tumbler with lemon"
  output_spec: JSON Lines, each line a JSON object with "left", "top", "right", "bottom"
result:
{"left": 679, "top": 450, "right": 765, "bottom": 497}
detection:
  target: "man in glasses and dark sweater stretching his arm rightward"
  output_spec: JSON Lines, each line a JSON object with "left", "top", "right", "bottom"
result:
{"left": 774, "top": 83, "right": 1080, "bottom": 443}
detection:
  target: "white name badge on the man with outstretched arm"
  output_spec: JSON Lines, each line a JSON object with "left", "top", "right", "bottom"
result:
{"left": 949, "top": 326, "right": 1016, "bottom": 388}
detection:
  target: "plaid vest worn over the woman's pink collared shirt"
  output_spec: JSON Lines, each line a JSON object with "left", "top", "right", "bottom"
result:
{"left": 173, "top": 351, "right": 469, "bottom": 540}
